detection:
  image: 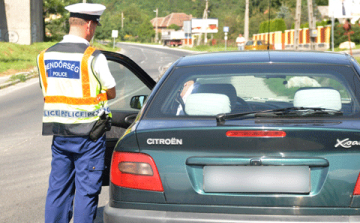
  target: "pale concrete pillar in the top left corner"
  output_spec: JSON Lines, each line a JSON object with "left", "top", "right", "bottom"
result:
{"left": 0, "top": 0, "right": 44, "bottom": 45}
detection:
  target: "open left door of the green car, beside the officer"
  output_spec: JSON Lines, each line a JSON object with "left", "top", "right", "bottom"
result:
{"left": 102, "top": 51, "right": 156, "bottom": 186}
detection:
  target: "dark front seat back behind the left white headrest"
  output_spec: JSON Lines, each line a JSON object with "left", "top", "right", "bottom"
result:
{"left": 193, "top": 84, "right": 237, "bottom": 109}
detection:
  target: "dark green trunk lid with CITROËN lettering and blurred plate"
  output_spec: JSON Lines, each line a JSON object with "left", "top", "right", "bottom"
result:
{"left": 137, "top": 121, "right": 360, "bottom": 207}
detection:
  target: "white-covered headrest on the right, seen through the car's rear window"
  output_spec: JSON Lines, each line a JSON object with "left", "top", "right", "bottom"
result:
{"left": 294, "top": 88, "right": 342, "bottom": 110}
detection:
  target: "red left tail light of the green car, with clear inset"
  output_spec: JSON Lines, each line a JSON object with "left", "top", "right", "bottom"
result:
{"left": 110, "top": 152, "right": 164, "bottom": 192}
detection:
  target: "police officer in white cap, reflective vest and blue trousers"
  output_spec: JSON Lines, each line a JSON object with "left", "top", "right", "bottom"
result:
{"left": 37, "top": 3, "right": 116, "bottom": 223}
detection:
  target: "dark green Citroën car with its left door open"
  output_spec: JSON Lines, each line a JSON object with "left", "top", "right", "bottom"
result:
{"left": 104, "top": 51, "right": 360, "bottom": 223}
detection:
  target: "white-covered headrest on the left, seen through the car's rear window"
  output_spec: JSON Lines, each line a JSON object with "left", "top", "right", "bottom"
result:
{"left": 185, "top": 93, "right": 231, "bottom": 115}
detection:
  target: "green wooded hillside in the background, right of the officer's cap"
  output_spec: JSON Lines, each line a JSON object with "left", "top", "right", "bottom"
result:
{"left": 88, "top": 0, "right": 328, "bottom": 39}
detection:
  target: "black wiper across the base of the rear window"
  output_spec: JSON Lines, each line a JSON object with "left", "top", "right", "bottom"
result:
{"left": 216, "top": 107, "right": 343, "bottom": 125}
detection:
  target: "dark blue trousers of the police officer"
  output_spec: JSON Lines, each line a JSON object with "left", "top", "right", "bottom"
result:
{"left": 45, "top": 136, "right": 105, "bottom": 223}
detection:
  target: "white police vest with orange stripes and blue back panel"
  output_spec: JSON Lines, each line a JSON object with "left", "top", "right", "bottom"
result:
{"left": 38, "top": 47, "right": 110, "bottom": 136}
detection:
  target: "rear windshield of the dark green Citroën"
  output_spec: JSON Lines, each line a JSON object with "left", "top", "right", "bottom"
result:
{"left": 145, "top": 64, "right": 360, "bottom": 118}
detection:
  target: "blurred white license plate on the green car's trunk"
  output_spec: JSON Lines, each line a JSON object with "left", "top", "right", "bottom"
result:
{"left": 203, "top": 166, "right": 311, "bottom": 193}
